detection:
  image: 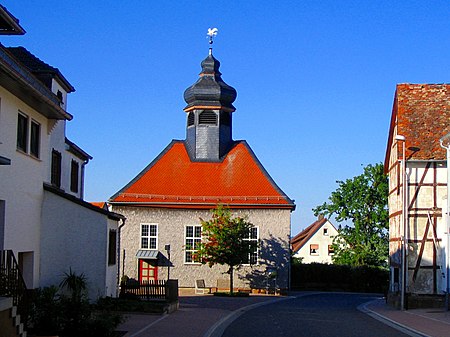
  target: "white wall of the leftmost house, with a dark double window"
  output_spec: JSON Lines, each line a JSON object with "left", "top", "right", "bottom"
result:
{"left": 0, "top": 87, "right": 48, "bottom": 287}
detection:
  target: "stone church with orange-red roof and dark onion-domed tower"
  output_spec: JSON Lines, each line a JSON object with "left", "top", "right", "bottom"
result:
{"left": 108, "top": 41, "right": 295, "bottom": 290}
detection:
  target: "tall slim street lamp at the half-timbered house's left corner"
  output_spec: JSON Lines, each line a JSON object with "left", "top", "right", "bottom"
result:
{"left": 395, "top": 135, "right": 408, "bottom": 310}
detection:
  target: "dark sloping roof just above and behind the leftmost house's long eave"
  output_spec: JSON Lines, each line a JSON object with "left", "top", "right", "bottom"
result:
{"left": 6, "top": 47, "right": 75, "bottom": 92}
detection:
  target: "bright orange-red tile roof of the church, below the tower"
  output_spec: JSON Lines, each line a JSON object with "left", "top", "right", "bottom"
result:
{"left": 110, "top": 141, "right": 295, "bottom": 210}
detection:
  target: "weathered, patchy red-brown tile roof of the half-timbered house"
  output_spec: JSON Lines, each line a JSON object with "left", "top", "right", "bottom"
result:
{"left": 385, "top": 83, "right": 450, "bottom": 169}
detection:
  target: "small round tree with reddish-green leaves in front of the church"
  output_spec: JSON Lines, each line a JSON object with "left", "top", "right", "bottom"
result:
{"left": 194, "top": 205, "right": 255, "bottom": 293}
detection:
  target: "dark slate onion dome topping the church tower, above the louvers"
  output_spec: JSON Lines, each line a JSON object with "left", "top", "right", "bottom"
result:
{"left": 184, "top": 50, "right": 237, "bottom": 112}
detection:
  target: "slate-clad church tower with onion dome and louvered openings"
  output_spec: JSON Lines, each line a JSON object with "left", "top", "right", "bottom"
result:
{"left": 184, "top": 52, "right": 237, "bottom": 161}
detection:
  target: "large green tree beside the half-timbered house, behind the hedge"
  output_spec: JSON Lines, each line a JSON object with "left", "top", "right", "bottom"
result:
{"left": 313, "top": 163, "right": 389, "bottom": 267}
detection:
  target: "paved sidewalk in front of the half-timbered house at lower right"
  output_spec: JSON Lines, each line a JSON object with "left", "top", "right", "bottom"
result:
{"left": 359, "top": 299, "right": 450, "bottom": 337}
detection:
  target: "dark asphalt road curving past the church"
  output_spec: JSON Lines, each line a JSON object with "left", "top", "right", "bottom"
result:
{"left": 223, "top": 293, "right": 407, "bottom": 337}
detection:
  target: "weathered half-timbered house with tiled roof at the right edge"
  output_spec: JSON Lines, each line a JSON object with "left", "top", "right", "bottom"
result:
{"left": 385, "top": 84, "right": 450, "bottom": 308}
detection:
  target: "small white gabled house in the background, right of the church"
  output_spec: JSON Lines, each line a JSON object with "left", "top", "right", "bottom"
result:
{"left": 291, "top": 216, "right": 338, "bottom": 264}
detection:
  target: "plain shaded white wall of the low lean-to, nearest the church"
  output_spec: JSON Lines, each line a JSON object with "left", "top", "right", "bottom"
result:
{"left": 40, "top": 191, "right": 117, "bottom": 299}
